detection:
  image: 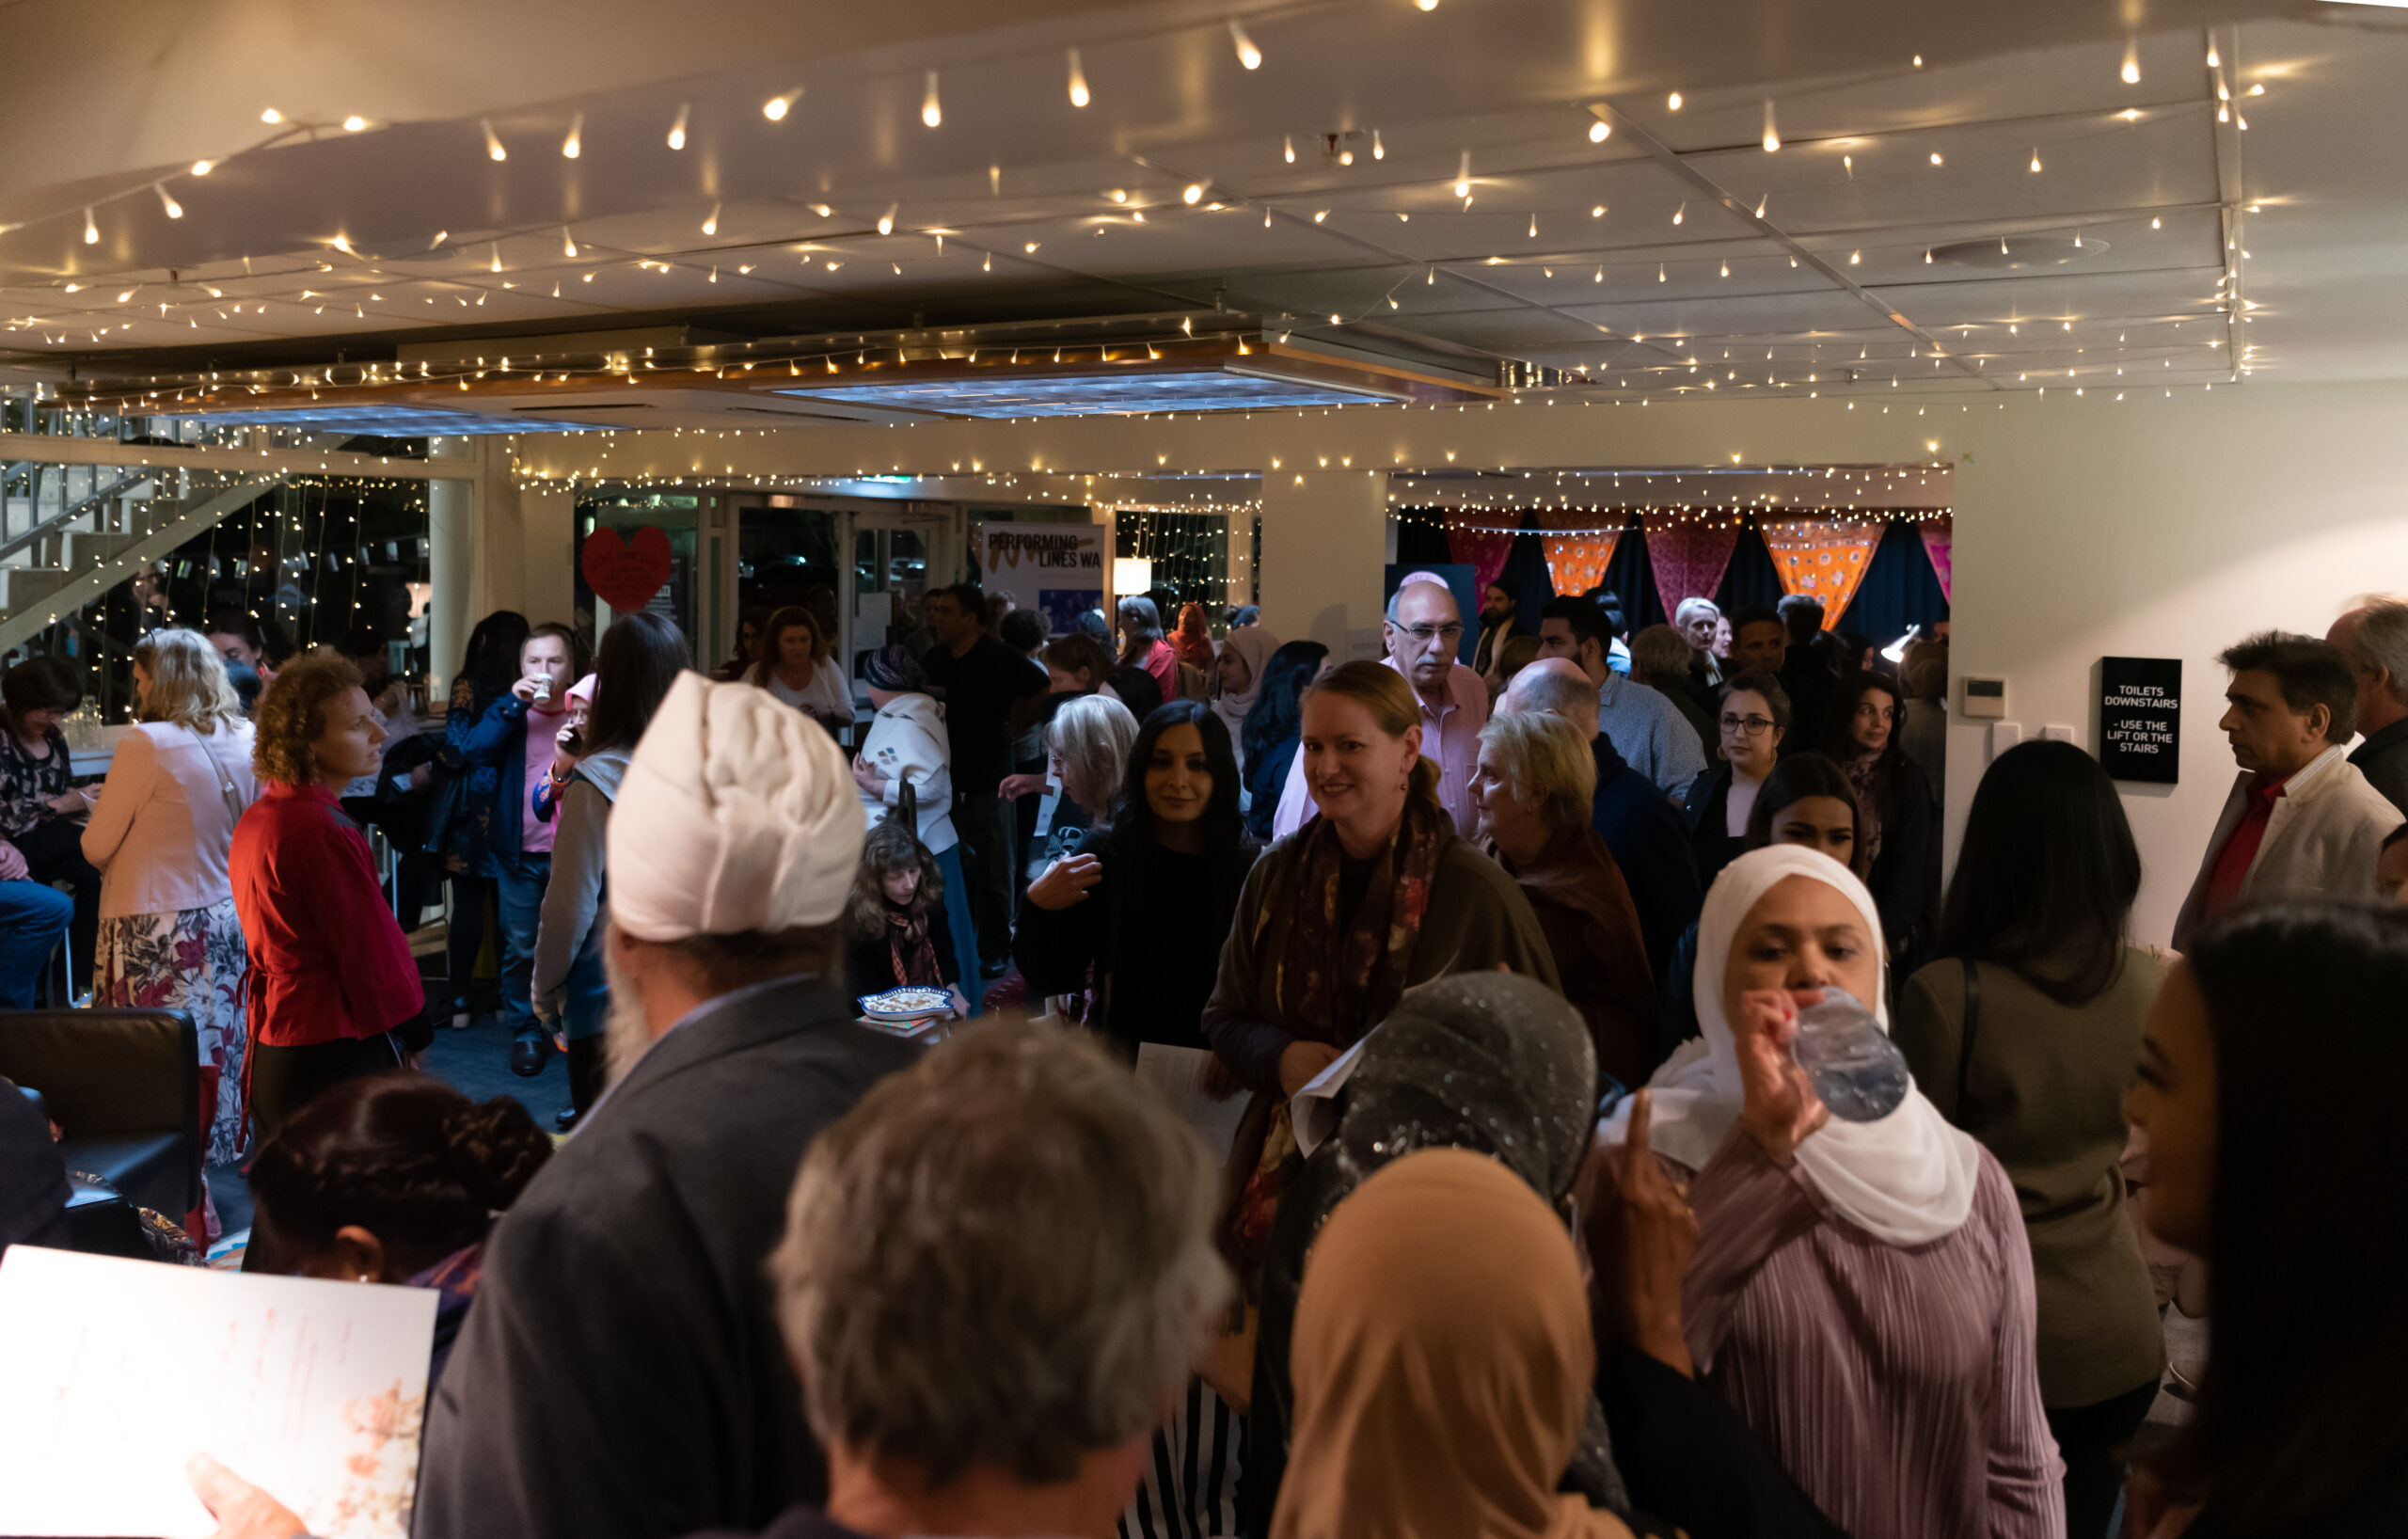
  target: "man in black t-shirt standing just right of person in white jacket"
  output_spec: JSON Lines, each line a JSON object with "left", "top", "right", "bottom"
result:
{"left": 920, "top": 583, "right": 1045, "bottom": 977}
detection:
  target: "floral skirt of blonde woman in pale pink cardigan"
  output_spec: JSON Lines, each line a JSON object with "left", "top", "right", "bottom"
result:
{"left": 91, "top": 898, "right": 250, "bottom": 1166}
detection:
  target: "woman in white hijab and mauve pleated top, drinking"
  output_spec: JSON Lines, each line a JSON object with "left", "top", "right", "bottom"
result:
{"left": 1601, "top": 846, "right": 2066, "bottom": 1539}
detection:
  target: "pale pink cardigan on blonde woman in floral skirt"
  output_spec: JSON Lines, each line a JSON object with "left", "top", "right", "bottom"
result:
{"left": 85, "top": 722, "right": 258, "bottom": 920}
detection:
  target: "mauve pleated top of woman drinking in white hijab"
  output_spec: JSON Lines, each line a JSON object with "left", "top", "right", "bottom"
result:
{"left": 1681, "top": 1127, "right": 2066, "bottom": 1539}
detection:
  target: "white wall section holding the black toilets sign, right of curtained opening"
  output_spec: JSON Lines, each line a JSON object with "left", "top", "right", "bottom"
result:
{"left": 1948, "top": 383, "right": 2408, "bottom": 944}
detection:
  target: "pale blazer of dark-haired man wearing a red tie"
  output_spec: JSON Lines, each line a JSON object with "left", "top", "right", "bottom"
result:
{"left": 2175, "top": 747, "right": 2400, "bottom": 951}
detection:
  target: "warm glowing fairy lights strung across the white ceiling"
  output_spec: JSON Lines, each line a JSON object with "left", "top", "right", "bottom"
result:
{"left": 0, "top": 16, "right": 2275, "bottom": 409}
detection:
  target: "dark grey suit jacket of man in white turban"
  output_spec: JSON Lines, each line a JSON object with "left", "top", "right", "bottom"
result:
{"left": 414, "top": 977, "right": 920, "bottom": 1539}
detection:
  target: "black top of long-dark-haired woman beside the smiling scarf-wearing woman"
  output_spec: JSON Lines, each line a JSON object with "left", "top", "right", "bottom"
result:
{"left": 1011, "top": 829, "right": 1255, "bottom": 1057}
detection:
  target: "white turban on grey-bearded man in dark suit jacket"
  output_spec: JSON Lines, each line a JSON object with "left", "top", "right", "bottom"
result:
{"left": 610, "top": 672, "right": 867, "bottom": 942}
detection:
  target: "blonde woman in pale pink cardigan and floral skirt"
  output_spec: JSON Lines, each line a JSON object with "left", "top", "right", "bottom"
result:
{"left": 85, "top": 631, "right": 258, "bottom": 1228}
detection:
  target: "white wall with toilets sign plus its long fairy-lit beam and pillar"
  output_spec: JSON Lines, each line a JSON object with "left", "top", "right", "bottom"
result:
{"left": 520, "top": 378, "right": 2408, "bottom": 942}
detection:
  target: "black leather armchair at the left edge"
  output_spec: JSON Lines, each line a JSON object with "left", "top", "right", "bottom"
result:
{"left": 0, "top": 1009, "right": 202, "bottom": 1224}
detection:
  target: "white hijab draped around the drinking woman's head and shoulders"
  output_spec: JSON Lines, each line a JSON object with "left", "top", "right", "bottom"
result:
{"left": 1599, "top": 846, "right": 1982, "bottom": 1245}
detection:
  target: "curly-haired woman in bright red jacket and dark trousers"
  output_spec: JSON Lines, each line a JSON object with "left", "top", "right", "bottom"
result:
{"left": 229, "top": 653, "right": 426, "bottom": 1142}
